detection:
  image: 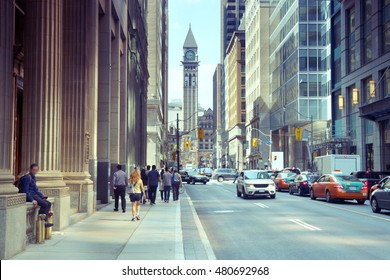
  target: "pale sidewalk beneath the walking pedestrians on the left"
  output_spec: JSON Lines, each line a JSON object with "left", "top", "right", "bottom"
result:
{"left": 13, "top": 200, "right": 185, "bottom": 260}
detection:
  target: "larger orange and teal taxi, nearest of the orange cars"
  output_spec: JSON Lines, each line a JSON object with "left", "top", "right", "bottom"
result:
{"left": 310, "top": 174, "right": 367, "bottom": 204}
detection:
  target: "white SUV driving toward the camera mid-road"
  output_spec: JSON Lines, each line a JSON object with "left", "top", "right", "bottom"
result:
{"left": 236, "top": 170, "right": 276, "bottom": 198}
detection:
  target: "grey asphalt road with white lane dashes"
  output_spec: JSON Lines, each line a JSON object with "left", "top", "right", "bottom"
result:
{"left": 185, "top": 181, "right": 390, "bottom": 260}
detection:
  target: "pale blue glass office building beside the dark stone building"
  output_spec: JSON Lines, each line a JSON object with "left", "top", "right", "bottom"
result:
{"left": 270, "top": 0, "right": 331, "bottom": 168}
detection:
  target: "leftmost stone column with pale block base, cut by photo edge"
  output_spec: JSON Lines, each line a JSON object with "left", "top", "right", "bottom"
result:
{"left": 0, "top": 0, "right": 26, "bottom": 260}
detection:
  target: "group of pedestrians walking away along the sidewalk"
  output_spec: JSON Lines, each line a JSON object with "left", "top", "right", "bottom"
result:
{"left": 112, "top": 165, "right": 182, "bottom": 221}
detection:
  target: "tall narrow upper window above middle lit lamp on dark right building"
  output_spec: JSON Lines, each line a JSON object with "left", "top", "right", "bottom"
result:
{"left": 346, "top": 7, "right": 357, "bottom": 73}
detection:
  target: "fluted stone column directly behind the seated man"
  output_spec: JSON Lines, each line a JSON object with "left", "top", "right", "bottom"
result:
{"left": 22, "top": 0, "right": 70, "bottom": 230}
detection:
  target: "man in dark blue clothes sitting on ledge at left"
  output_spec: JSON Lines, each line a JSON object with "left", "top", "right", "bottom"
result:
{"left": 20, "top": 163, "right": 53, "bottom": 227}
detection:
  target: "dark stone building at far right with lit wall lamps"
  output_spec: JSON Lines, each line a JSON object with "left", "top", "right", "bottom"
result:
{"left": 331, "top": 0, "right": 390, "bottom": 172}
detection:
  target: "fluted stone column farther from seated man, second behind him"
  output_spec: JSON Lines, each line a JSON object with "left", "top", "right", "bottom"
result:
{"left": 61, "top": 0, "right": 98, "bottom": 217}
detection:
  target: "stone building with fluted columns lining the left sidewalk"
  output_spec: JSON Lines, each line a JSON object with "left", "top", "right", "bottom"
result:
{"left": 0, "top": 0, "right": 148, "bottom": 259}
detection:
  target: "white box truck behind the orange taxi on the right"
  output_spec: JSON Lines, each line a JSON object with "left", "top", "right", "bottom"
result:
{"left": 314, "top": 155, "right": 360, "bottom": 175}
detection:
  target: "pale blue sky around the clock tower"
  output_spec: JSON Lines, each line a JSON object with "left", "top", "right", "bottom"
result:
{"left": 168, "top": 0, "right": 220, "bottom": 109}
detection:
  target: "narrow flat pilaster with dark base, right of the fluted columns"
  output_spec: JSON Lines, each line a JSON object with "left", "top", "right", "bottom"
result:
{"left": 97, "top": 0, "right": 112, "bottom": 203}
